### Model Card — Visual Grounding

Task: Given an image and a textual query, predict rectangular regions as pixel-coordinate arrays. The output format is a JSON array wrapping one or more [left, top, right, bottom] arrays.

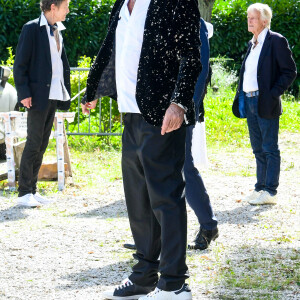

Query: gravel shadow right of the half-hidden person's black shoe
[[215, 204, 273, 224]]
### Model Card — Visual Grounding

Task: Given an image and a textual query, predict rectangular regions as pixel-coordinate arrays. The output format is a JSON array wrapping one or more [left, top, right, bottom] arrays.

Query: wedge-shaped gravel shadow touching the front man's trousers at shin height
[[74, 199, 128, 219]]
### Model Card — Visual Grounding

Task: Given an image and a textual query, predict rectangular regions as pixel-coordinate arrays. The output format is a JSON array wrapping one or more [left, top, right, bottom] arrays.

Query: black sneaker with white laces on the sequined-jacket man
[[102, 278, 154, 300]]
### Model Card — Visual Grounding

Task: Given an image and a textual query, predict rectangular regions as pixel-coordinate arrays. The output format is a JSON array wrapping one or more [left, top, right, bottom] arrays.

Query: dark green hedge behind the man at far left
[[0, 0, 114, 66]]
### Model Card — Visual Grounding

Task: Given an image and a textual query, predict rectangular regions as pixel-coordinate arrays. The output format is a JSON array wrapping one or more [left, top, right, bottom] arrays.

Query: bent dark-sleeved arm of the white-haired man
[[271, 37, 297, 97]]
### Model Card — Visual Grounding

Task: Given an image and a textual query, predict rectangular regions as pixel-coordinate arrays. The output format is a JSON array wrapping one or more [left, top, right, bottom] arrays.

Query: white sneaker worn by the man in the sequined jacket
[[139, 283, 192, 300]]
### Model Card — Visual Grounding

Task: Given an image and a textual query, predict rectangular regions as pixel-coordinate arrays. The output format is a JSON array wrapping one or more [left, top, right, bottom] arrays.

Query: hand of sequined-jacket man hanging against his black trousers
[[161, 103, 184, 135]]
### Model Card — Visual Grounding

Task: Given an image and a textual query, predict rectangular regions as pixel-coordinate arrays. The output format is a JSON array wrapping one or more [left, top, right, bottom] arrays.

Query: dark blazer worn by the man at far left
[[13, 18, 71, 110]]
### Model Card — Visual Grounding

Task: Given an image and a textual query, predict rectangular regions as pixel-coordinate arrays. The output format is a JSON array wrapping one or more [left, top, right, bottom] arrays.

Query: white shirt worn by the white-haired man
[[243, 28, 269, 93]]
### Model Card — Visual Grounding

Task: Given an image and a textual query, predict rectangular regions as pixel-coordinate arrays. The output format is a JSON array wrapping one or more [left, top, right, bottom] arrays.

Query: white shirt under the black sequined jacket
[[116, 0, 150, 113]]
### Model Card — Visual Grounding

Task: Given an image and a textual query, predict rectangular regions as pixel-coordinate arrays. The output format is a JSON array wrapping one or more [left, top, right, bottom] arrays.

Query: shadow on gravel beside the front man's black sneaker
[[55, 258, 134, 290]]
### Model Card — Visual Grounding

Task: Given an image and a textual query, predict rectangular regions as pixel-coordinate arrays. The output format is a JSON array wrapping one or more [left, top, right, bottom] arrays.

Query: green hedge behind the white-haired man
[[211, 0, 300, 95]]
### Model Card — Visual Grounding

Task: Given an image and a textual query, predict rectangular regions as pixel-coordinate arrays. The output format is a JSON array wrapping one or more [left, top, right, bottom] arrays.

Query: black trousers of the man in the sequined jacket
[[122, 113, 188, 291]]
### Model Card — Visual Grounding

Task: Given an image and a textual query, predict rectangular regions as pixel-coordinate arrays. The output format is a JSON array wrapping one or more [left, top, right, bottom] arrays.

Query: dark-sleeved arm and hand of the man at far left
[[13, 25, 33, 103]]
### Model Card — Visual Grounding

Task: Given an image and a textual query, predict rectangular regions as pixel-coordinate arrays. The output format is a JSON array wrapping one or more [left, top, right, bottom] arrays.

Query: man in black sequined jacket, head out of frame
[[82, 0, 201, 300]]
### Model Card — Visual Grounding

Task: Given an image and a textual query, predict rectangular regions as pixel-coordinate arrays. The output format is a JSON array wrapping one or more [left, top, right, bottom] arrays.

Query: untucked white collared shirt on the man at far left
[[40, 13, 70, 101]]
